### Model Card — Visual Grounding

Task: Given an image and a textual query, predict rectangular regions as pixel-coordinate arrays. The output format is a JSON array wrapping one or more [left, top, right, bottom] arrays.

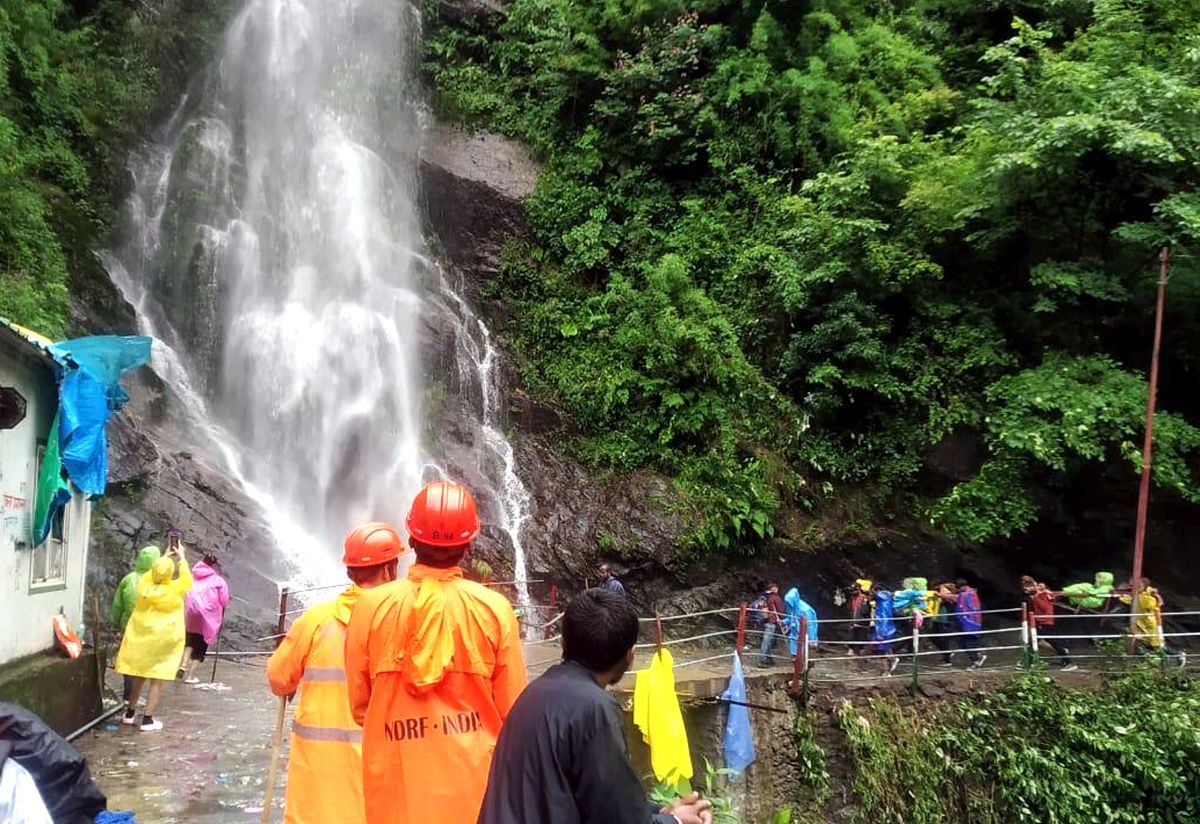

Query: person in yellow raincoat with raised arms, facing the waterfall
[[116, 539, 192, 733]]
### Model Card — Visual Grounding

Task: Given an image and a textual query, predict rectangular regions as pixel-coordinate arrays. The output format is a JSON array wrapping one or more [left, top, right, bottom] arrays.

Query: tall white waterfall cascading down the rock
[[101, 0, 529, 603]]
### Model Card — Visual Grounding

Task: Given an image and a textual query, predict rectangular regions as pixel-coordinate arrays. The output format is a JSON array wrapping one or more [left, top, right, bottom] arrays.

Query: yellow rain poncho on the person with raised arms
[[116, 558, 192, 681]]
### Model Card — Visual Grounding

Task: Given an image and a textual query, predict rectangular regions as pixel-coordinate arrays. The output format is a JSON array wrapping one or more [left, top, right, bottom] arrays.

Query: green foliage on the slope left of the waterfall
[[0, 0, 227, 336]]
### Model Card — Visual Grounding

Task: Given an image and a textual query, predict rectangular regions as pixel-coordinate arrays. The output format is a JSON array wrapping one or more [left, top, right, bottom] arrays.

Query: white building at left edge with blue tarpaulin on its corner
[[0, 320, 91, 664]]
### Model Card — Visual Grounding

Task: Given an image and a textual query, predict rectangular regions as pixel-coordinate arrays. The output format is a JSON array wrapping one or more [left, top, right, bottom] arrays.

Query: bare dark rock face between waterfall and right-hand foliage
[[420, 124, 682, 599]]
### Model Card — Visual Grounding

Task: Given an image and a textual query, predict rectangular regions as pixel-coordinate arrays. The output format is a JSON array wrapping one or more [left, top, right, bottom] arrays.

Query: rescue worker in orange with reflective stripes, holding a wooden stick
[[266, 523, 404, 824]]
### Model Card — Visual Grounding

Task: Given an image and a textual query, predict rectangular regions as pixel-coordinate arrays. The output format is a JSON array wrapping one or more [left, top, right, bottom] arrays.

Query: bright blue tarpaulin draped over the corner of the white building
[[35, 335, 151, 546]]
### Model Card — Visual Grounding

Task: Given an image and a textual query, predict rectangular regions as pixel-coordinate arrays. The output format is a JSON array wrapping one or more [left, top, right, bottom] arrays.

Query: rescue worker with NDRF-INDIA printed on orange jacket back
[[346, 481, 526, 824]]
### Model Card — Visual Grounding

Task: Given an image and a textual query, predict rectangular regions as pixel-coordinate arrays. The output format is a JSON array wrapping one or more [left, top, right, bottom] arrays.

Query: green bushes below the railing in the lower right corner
[[840, 670, 1200, 824]]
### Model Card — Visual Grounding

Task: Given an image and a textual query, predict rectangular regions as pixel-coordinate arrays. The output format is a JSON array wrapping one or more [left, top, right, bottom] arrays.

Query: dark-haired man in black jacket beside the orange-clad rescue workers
[[479, 589, 713, 824]]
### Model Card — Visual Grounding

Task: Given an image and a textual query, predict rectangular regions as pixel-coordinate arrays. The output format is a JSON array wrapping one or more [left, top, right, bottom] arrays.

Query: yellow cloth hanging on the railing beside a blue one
[[634, 649, 692, 784]]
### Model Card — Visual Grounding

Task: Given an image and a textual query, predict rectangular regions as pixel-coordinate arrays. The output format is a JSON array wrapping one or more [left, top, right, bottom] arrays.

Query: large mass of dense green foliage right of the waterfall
[[425, 0, 1200, 548]]
